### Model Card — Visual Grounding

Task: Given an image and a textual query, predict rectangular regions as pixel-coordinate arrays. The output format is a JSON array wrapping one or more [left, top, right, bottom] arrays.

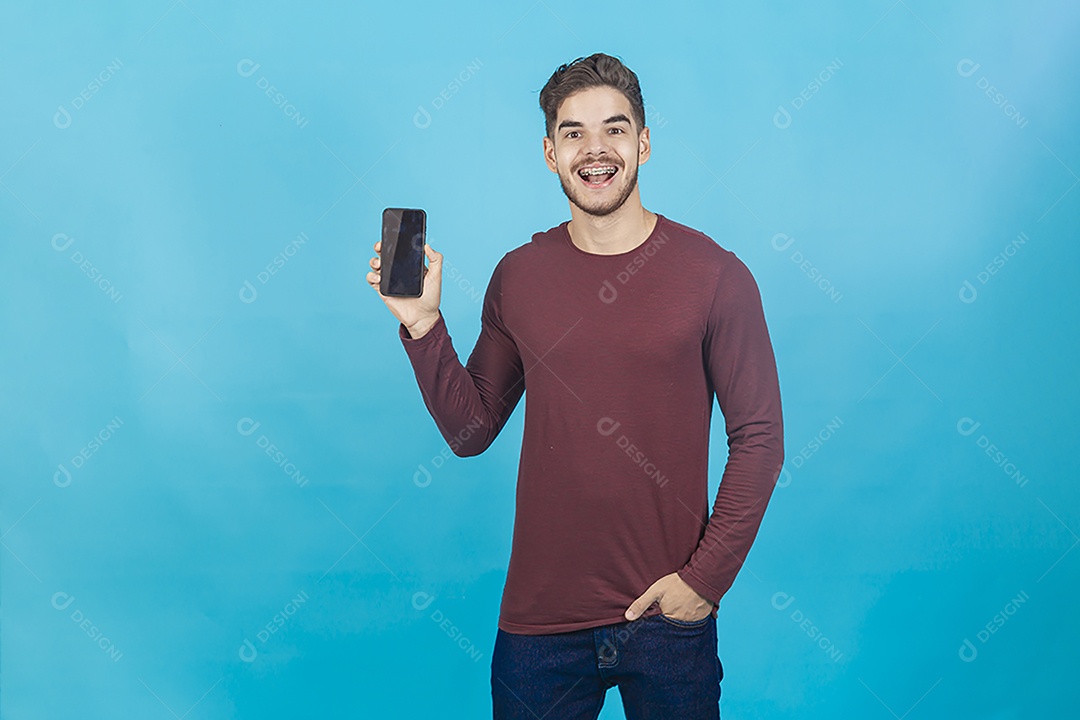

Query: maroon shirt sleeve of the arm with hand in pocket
[[678, 252, 784, 612]]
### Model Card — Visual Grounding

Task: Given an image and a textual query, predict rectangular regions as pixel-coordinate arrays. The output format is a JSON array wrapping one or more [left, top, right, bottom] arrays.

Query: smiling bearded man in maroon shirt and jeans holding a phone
[[367, 53, 784, 719]]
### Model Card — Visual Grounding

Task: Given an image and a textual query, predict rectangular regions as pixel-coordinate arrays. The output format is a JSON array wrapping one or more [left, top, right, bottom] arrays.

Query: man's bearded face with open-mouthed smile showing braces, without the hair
[[543, 86, 649, 216]]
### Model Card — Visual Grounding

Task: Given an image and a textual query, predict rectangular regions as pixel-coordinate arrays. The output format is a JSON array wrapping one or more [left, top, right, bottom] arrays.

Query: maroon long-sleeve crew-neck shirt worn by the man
[[399, 214, 784, 635]]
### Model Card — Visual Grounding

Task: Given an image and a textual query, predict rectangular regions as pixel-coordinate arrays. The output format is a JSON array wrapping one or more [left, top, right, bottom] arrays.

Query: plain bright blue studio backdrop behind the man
[[0, 0, 1080, 720]]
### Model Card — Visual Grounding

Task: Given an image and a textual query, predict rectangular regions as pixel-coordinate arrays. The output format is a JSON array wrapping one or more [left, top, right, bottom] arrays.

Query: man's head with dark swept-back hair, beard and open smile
[[540, 53, 649, 216]]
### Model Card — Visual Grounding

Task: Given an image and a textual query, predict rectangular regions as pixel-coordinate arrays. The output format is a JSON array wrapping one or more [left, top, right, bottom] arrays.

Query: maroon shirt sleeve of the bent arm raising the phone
[[397, 257, 525, 458]]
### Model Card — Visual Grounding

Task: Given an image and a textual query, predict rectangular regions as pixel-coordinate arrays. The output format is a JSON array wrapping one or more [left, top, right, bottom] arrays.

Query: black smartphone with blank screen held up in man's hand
[[379, 207, 428, 298]]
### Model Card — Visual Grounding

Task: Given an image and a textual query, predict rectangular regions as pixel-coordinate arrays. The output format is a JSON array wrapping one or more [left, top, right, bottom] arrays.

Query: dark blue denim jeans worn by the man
[[491, 615, 724, 720]]
